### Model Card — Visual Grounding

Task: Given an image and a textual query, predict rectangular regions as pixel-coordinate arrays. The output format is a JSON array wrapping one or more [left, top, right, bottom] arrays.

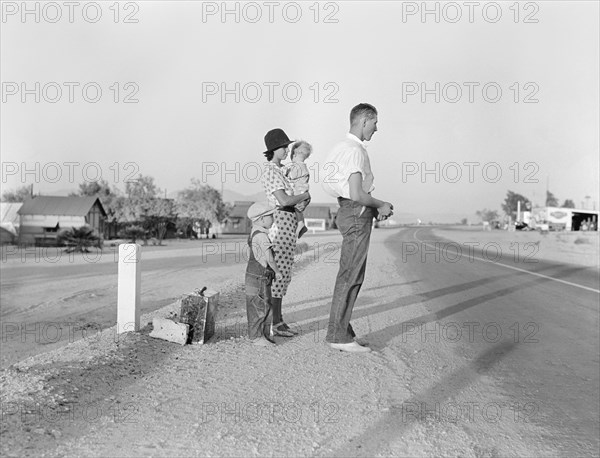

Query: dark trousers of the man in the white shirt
[[325, 198, 377, 343]]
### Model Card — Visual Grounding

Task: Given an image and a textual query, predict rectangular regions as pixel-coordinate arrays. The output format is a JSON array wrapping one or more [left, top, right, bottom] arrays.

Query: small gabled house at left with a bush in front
[[18, 196, 107, 245]]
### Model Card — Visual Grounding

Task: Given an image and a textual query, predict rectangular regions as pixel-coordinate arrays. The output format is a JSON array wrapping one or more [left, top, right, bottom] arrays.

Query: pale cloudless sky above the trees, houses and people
[[0, 1, 600, 222]]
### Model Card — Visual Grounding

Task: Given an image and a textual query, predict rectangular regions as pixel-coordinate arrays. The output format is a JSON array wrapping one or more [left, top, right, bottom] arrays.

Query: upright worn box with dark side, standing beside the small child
[[180, 290, 219, 344]]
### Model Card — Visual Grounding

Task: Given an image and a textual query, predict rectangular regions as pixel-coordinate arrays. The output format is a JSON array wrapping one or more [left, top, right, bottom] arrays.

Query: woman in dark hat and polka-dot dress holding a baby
[[261, 129, 310, 337]]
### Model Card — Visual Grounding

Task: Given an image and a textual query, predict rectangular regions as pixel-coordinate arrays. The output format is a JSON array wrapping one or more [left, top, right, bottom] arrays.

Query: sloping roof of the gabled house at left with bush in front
[[18, 196, 106, 216]]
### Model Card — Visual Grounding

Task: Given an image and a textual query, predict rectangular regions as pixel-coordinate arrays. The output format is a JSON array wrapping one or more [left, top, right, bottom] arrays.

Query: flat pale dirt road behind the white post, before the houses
[[0, 232, 339, 368]]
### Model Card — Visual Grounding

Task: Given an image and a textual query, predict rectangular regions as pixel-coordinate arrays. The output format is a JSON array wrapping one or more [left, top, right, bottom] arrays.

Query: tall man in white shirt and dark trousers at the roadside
[[323, 103, 394, 353]]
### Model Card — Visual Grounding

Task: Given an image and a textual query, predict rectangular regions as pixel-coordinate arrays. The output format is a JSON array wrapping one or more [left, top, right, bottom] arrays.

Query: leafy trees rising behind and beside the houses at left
[[2, 175, 230, 247]]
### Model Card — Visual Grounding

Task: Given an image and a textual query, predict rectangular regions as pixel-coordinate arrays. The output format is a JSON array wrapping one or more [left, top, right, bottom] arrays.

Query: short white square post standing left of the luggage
[[117, 243, 142, 334]]
